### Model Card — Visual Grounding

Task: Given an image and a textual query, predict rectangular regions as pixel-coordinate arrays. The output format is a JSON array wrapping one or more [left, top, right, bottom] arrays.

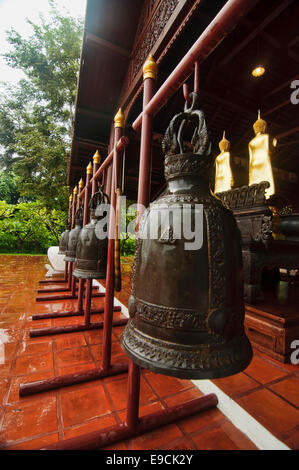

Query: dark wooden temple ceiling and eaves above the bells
[[70, 0, 299, 207]]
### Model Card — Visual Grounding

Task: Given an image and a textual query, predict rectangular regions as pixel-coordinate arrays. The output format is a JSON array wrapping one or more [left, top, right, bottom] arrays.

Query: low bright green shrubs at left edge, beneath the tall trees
[[0, 201, 66, 253]]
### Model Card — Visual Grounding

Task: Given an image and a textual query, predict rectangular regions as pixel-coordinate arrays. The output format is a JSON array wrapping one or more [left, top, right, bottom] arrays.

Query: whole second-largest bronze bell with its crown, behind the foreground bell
[[73, 190, 109, 279]]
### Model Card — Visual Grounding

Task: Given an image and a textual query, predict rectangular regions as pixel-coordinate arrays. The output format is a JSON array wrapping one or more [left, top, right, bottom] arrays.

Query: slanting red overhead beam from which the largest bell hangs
[[133, 0, 258, 130]]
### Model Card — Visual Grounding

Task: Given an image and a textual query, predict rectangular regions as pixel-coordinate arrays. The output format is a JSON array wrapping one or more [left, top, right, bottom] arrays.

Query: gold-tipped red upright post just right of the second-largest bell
[[102, 109, 124, 370]]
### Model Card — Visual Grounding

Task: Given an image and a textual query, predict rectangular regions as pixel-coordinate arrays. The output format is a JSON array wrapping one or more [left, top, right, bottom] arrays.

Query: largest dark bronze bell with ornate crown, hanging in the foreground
[[122, 93, 252, 379]]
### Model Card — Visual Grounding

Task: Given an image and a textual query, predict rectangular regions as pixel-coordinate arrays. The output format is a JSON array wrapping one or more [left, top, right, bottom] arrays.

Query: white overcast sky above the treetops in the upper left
[[0, 0, 86, 84]]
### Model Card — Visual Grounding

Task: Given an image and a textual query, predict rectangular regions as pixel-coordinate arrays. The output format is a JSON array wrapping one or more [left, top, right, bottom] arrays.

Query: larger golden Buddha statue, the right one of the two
[[248, 111, 274, 199]]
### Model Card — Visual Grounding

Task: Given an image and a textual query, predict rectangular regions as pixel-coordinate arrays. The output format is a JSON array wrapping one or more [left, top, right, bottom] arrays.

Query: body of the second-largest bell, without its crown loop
[[73, 217, 108, 279]]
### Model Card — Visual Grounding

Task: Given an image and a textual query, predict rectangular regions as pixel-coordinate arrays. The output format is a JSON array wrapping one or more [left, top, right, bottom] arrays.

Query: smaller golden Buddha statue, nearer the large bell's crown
[[214, 131, 234, 194]]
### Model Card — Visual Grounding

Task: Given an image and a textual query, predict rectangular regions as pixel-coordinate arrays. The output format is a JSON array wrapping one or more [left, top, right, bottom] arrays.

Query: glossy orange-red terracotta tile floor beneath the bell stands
[[0, 255, 299, 450]]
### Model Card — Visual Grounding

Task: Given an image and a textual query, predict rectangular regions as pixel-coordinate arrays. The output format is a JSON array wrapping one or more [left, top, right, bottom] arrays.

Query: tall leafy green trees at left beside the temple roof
[[0, 0, 83, 209]]
